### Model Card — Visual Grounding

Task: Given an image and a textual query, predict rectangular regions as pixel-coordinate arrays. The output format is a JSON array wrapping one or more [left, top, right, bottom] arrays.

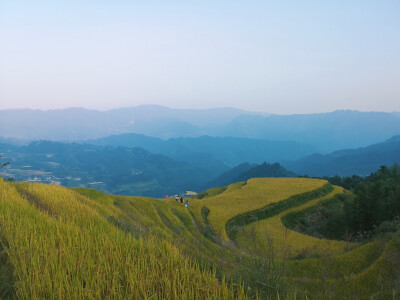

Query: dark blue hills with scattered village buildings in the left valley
[[0, 142, 211, 197]]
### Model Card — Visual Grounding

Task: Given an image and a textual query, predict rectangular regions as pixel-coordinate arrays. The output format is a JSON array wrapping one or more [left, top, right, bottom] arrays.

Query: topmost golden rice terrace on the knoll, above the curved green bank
[[191, 178, 327, 240]]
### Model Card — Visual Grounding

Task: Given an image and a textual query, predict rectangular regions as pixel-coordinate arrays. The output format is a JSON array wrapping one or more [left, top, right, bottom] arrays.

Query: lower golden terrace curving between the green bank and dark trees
[[237, 186, 351, 257]]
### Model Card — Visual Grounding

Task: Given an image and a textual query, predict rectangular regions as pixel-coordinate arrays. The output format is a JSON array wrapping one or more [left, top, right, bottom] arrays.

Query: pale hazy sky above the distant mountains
[[0, 0, 400, 114]]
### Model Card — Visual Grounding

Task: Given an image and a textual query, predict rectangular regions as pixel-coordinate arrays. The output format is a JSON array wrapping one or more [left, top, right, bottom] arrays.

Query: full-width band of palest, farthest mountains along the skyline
[[0, 106, 400, 152]]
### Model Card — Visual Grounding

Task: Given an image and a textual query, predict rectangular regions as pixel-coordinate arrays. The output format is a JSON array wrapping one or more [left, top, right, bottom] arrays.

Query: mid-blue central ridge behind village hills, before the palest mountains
[[87, 134, 316, 171]]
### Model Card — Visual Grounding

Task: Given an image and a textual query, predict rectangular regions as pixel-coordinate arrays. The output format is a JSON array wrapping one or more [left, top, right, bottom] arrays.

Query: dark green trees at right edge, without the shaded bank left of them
[[328, 164, 400, 238]]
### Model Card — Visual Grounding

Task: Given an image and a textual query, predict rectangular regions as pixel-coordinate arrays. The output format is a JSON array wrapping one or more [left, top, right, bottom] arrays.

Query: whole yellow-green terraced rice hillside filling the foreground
[[0, 178, 400, 299]]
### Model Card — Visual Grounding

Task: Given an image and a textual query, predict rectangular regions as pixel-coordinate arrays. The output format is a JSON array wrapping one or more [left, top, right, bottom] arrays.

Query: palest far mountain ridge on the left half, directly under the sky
[[0, 105, 252, 141]]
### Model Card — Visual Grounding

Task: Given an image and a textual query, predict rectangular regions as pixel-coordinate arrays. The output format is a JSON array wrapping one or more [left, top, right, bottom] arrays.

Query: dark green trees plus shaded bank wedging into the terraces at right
[[287, 164, 400, 241]]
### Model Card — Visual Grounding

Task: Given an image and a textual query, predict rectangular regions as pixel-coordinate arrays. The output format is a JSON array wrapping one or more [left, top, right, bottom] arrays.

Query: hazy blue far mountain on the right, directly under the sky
[[218, 110, 400, 153]]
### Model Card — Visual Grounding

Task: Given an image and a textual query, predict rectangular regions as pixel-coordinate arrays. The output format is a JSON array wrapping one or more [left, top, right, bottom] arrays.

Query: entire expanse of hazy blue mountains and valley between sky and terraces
[[0, 106, 400, 197]]
